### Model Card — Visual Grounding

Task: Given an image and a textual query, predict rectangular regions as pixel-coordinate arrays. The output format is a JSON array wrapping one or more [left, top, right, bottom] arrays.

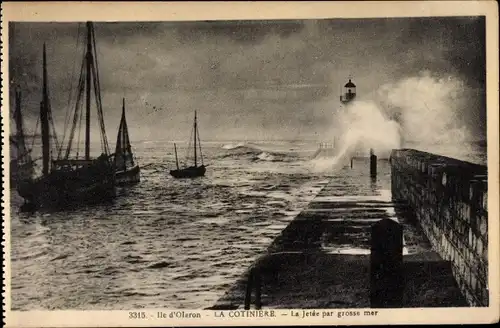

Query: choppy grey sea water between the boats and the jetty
[[11, 142, 484, 310]]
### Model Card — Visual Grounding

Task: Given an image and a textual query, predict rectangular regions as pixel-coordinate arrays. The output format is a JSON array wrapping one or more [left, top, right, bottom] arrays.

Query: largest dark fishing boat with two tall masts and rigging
[[17, 22, 116, 209]]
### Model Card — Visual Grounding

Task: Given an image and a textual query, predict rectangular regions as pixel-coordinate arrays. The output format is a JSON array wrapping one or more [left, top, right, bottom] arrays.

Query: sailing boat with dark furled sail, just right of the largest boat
[[114, 98, 141, 185]]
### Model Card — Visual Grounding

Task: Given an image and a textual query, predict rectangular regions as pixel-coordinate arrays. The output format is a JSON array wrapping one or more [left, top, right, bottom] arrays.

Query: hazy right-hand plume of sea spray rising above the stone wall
[[377, 71, 474, 157]]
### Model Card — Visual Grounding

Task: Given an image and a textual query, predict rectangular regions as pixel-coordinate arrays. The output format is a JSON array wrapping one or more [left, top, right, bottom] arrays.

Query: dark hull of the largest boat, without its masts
[[17, 161, 116, 209]]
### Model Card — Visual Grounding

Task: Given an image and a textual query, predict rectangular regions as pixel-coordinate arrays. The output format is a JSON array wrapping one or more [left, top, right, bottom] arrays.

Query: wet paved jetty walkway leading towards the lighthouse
[[209, 159, 467, 309]]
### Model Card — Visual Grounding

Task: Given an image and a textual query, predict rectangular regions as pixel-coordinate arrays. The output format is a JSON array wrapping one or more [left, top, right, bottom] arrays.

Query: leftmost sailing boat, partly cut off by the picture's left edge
[[10, 90, 34, 188]]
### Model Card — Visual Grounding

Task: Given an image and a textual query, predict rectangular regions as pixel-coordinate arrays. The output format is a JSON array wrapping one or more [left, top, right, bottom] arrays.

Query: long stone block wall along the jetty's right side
[[391, 149, 489, 306]]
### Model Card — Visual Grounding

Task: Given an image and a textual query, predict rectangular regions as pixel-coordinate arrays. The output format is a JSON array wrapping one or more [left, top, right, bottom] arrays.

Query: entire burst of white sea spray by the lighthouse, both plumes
[[310, 71, 476, 172]]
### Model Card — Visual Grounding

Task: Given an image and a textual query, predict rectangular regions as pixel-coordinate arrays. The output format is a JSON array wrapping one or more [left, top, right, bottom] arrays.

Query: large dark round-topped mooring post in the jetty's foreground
[[370, 219, 404, 308]]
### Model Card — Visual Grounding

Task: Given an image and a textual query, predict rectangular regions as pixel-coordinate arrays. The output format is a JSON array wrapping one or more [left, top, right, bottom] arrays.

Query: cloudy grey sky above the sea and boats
[[9, 17, 486, 144]]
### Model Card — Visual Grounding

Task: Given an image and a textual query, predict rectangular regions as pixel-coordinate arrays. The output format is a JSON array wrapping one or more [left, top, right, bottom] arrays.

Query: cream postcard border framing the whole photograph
[[2, 1, 500, 327]]
